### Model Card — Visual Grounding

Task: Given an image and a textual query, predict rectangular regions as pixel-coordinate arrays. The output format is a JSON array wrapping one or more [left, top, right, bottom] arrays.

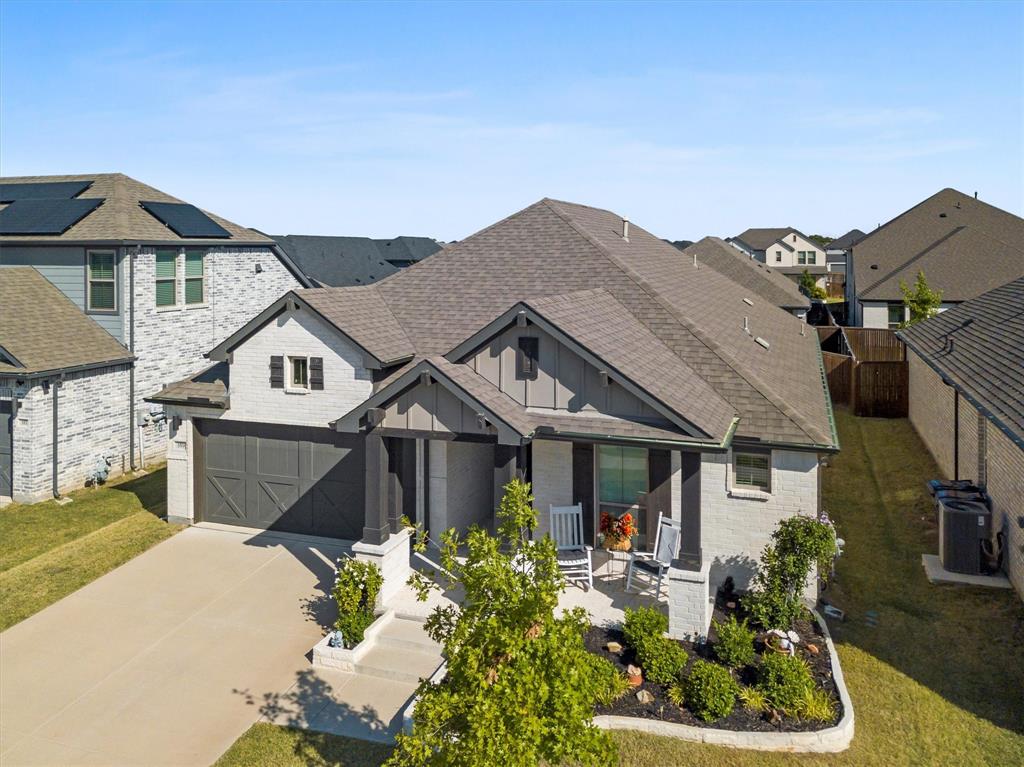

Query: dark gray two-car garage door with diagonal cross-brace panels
[[196, 420, 365, 541]]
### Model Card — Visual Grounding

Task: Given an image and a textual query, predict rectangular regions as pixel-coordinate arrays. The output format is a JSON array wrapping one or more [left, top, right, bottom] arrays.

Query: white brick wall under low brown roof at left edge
[[0, 365, 128, 503]]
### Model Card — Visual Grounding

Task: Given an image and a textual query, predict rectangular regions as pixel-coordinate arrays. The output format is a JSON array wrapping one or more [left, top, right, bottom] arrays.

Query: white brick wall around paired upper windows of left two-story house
[[128, 248, 301, 463]]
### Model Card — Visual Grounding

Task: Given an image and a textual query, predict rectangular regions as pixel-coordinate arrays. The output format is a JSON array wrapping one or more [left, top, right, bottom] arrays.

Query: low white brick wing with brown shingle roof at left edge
[[0, 266, 132, 502]]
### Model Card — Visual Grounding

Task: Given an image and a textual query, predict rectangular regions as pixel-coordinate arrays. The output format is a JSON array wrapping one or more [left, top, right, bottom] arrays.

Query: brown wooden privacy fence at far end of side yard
[[818, 328, 909, 418]]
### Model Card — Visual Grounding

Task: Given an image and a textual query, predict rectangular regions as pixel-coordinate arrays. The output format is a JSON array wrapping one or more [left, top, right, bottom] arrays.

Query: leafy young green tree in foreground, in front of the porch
[[387, 479, 616, 767]]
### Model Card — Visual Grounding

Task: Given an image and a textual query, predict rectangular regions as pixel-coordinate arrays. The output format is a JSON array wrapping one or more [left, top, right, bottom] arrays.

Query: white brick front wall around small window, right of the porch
[[700, 450, 818, 592]]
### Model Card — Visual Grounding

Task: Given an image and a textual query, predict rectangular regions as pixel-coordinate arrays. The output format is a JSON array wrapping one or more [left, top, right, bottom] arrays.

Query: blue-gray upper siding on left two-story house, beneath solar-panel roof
[[0, 245, 125, 343]]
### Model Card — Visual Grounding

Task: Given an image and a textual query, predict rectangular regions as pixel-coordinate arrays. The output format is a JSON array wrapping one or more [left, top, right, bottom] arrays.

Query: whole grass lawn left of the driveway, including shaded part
[[0, 469, 179, 631]]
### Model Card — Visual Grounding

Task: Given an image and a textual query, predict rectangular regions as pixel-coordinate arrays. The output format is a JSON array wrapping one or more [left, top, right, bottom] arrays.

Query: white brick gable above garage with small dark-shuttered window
[[226, 309, 373, 427]]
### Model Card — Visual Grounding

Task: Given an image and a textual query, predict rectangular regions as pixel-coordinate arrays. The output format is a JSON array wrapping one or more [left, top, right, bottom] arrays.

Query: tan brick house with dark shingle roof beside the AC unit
[[898, 278, 1024, 597]]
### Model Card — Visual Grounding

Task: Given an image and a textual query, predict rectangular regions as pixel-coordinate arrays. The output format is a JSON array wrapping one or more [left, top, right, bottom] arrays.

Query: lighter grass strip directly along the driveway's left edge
[[0, 511, 180, 631]]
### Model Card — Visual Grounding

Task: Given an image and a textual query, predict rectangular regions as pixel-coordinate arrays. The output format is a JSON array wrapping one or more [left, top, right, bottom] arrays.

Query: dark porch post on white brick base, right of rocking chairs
[[669, 453, 714, 641]]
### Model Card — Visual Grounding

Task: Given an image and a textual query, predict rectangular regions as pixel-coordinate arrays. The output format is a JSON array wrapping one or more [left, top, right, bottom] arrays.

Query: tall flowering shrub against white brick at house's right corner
[[744, 515, 838, 629]]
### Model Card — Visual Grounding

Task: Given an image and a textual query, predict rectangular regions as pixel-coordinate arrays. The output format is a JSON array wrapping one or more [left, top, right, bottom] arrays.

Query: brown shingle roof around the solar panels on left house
[[0, 173, 273, 245]]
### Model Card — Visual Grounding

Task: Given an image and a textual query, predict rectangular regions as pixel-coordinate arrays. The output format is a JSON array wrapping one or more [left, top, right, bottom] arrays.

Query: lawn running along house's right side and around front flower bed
[[218, 411, 1024, 767]]
